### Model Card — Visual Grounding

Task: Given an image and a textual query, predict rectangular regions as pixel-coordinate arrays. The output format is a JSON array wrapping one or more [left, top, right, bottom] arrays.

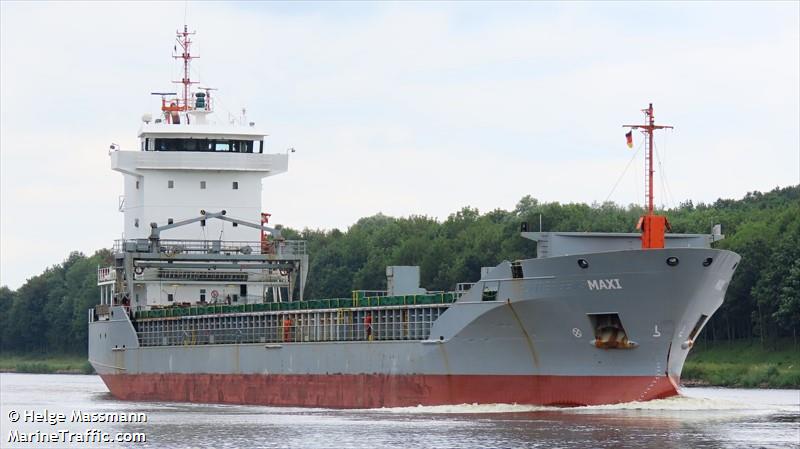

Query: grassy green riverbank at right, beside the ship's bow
[[681, 340, 800, 388]]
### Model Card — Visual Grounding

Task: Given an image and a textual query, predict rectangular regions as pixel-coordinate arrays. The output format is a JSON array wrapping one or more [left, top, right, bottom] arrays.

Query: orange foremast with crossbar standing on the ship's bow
[[622, 103, 673, 249]]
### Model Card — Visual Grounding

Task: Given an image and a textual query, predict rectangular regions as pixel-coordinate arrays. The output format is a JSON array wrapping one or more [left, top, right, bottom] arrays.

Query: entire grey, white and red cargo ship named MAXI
[[88, 26, 740, 408]]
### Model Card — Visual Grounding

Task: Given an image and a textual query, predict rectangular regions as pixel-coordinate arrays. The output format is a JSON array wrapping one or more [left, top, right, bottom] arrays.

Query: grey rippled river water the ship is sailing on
[[0, 374, 800, 448]]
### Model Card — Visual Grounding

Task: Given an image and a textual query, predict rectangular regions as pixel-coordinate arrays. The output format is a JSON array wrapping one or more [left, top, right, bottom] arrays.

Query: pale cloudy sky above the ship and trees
[[0, 1, 800, 289]]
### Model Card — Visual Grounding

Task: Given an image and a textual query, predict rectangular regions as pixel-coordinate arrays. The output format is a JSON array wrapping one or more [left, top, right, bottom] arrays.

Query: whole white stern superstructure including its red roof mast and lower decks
[[98, 27, 308, 310]]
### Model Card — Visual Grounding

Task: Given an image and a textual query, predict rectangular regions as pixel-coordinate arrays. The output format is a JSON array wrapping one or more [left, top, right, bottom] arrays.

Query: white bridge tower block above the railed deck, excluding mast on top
[[111, 122, 288, 241]]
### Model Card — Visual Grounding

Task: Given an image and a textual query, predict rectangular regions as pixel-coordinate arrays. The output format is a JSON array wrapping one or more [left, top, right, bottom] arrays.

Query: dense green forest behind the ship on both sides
[[0, 186, 800, 354]]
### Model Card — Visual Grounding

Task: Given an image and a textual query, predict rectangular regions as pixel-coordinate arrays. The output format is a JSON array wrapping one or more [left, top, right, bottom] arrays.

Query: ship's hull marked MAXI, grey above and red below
[[89, 248, 740, 408]]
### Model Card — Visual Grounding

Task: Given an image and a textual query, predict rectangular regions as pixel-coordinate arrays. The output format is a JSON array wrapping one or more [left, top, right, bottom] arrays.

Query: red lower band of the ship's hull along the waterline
[[102, 374, 678, 408]]
